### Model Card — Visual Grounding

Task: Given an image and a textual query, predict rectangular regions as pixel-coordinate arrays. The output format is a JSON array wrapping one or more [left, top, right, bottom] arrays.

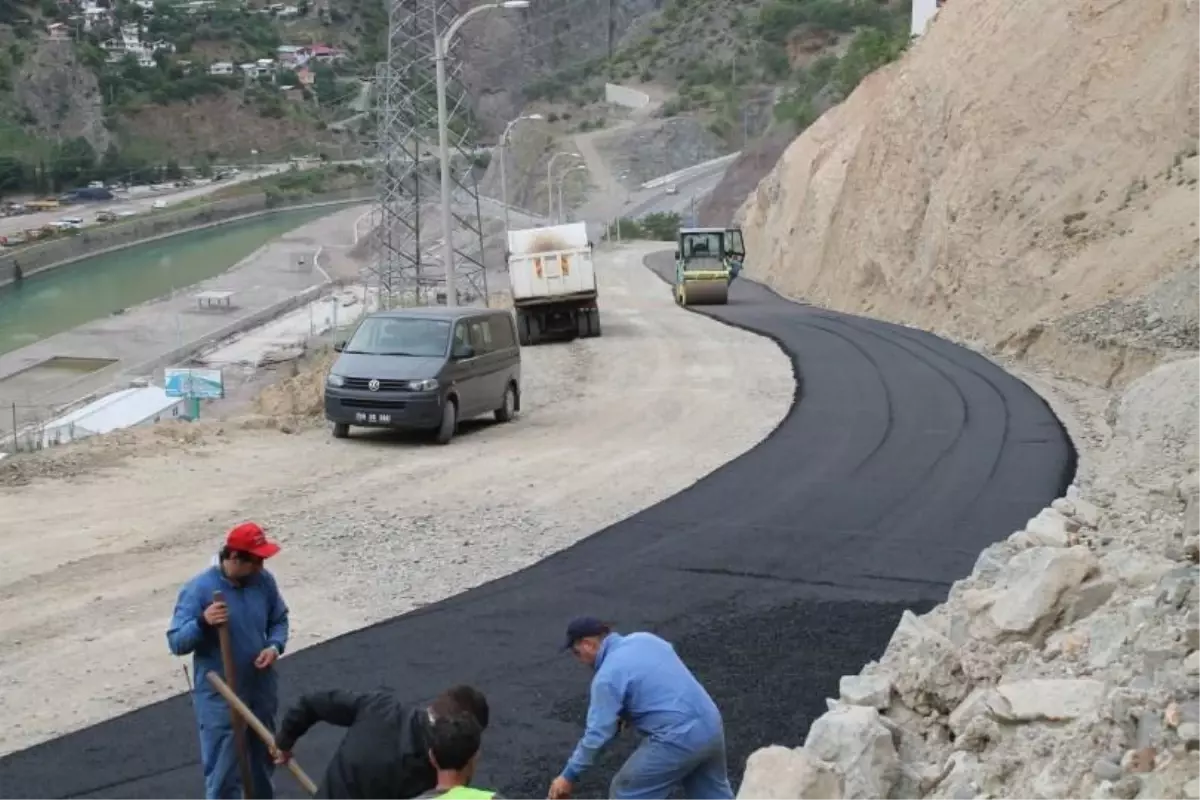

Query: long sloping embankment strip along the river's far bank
[[0, 188, 374, 287]]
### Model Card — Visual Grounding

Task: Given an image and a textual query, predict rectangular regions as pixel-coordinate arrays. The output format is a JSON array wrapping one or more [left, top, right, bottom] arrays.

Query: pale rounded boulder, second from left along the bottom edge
[[804, 705, 900, 800]]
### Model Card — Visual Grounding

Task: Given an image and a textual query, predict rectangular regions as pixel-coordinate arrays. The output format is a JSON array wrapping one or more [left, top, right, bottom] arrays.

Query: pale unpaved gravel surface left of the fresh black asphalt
[[0, 243, 794, 754]]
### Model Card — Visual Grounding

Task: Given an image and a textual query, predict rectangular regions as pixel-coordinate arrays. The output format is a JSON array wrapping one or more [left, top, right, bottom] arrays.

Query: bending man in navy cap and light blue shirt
[[548, 616, 733, 800]]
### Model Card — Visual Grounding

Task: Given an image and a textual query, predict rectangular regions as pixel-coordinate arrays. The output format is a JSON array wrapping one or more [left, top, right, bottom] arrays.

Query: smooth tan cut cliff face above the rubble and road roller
[[738, 0, 1200, 383]]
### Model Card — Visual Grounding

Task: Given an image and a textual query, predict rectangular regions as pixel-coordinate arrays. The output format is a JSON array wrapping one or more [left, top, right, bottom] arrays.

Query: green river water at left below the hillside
[[0, 207, 336, 354]]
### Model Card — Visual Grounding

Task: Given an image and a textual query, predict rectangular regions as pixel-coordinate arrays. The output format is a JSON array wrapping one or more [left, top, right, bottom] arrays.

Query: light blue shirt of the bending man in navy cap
[[563, 633, 722, 783]]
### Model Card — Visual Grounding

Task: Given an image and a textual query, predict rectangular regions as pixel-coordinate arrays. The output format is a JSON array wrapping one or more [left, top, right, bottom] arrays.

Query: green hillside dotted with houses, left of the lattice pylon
[[0, 0, 384, 192]]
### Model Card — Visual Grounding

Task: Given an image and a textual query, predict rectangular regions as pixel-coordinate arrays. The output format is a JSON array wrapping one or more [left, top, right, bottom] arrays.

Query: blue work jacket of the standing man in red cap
[[167, 566, 288, 724]]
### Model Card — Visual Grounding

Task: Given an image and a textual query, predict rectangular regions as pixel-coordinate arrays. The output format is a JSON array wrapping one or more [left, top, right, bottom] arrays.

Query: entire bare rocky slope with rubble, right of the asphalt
[[724, 0, 1200, 800]]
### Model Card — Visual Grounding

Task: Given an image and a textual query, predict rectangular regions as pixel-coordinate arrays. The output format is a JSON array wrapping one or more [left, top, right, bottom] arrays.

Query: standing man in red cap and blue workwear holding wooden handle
[[167, 522, 288, 800]]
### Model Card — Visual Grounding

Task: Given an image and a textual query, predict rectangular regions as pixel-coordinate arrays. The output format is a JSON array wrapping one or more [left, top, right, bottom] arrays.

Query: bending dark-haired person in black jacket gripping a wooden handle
[[275, 686, 488, 800]]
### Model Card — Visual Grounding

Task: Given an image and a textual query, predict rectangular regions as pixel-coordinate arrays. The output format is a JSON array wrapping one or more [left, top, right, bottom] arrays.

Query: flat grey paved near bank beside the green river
[[0, 204, 367, 449]]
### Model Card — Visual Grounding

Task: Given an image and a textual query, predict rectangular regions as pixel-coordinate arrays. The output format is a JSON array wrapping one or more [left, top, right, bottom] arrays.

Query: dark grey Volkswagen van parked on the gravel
[[325, 306, 521, 444]]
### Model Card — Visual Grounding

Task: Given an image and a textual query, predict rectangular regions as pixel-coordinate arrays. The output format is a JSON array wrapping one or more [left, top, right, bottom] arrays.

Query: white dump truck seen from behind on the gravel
[[508, 222, 600, 345]]
